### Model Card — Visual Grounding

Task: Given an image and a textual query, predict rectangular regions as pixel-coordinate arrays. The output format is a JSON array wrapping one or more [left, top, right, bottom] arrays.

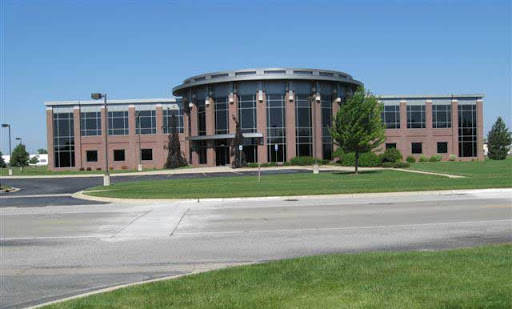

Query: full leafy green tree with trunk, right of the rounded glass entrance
[[330, 87, 386, 174]]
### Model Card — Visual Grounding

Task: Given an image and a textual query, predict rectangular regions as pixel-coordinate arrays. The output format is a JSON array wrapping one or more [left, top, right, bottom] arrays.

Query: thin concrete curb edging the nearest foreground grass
[[27, 262, 257, 309]]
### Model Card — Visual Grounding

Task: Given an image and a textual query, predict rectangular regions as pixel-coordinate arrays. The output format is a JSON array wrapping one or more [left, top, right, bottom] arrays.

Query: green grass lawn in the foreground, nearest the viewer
[[45, 244, 512, 309]]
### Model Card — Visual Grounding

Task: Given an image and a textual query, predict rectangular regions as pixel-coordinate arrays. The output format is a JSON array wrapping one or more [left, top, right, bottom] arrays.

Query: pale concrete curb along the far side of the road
[[72, 188, 512, 204]]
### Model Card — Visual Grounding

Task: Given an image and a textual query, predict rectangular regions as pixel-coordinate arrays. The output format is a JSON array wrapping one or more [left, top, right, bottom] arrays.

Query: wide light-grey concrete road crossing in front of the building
[[0, 190, 512, 308]]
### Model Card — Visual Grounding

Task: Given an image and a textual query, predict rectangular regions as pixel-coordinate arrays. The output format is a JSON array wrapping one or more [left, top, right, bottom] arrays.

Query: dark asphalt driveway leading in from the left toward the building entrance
[[0, 169, 310, 207]]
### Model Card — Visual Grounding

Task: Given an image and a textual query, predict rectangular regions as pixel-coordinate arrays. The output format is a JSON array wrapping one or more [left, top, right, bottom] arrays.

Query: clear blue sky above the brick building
[[0, 0, 512, 153]]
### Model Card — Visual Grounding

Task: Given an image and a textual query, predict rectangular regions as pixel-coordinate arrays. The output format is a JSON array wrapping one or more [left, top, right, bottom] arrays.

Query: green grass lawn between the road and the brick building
[[87, 160, 512, 199]]
